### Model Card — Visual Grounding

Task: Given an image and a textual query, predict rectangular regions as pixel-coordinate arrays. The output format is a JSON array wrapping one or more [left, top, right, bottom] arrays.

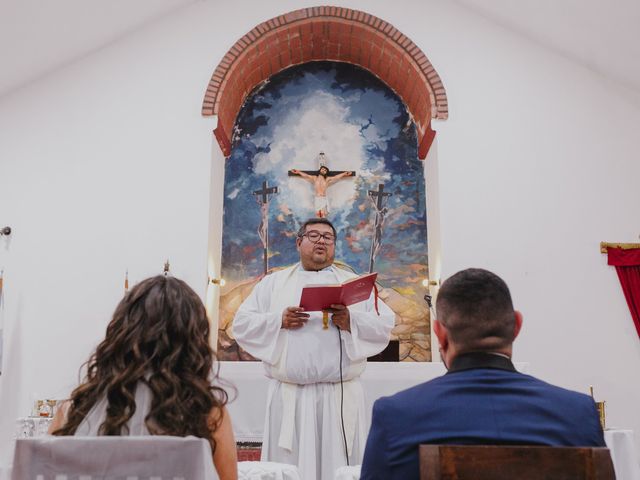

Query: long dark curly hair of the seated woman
[[53, 275, 228, 450]]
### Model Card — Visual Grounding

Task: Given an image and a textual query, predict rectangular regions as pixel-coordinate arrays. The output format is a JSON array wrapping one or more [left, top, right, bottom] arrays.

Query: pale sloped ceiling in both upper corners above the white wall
[[0, 0, 640, 97]]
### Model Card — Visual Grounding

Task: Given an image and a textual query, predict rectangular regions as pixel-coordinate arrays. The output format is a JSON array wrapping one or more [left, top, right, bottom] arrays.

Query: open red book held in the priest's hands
[[300, 272, 378, 312]]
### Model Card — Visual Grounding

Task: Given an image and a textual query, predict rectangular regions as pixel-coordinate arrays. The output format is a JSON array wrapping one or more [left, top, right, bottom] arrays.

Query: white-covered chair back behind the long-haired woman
[[11, 436, 218, 480]]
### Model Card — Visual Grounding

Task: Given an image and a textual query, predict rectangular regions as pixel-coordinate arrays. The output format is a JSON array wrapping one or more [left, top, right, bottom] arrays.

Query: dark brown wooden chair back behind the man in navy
[[420, 445, 615, 480]]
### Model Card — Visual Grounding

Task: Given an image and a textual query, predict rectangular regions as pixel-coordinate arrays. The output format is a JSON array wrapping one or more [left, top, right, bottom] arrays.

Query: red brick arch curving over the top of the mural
[[202, 7, 449, 159]]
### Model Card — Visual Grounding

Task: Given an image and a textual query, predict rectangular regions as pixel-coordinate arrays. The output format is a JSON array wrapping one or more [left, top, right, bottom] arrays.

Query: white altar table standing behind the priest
[[219, 362, 529, 442]]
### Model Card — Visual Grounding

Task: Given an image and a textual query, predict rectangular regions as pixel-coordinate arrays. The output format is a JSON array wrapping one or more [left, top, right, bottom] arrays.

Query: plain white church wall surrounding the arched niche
[[0, 1, 640, 465]]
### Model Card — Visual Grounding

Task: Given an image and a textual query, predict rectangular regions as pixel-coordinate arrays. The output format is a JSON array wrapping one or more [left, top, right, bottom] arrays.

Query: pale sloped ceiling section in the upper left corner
[[0, 0, 199, 97]]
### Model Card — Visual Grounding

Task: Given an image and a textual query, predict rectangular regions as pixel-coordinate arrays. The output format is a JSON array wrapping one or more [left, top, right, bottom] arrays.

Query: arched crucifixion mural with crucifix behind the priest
[[218, 62, 431, 361]]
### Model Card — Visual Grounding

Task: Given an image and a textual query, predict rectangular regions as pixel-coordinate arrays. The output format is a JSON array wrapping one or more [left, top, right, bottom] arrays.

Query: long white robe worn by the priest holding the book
[[233, 264, 394, 480]]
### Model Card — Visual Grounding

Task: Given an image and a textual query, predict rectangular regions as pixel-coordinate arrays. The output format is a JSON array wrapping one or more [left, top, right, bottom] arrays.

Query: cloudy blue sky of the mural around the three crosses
[[222, 62, 427, 296]]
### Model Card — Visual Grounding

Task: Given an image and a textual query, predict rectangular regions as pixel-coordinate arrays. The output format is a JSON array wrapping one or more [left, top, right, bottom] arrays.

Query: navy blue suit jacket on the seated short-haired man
[[360, 353, 605, 480]]
